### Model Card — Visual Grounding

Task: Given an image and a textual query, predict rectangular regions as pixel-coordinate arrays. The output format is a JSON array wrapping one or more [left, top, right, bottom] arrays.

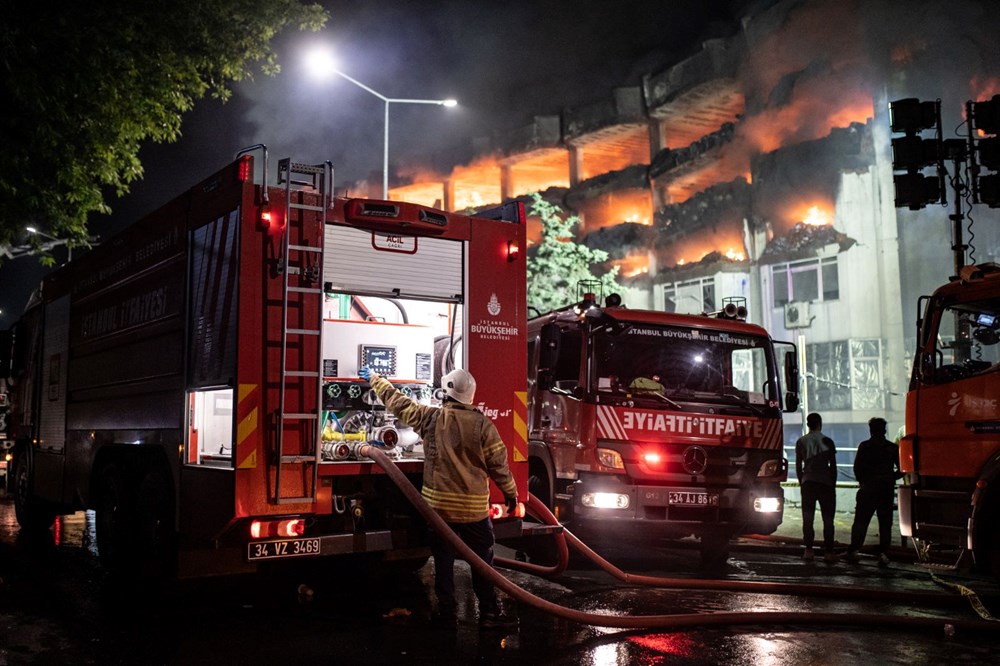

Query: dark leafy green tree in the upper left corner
[[0, 0, 327, 260]]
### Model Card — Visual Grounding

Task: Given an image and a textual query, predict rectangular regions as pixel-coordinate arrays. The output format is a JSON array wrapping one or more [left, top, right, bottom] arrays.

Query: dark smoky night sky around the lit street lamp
[[0, 0, 746, 327]]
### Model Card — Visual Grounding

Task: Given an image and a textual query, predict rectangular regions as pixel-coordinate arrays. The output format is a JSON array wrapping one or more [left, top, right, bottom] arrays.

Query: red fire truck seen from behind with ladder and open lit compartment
[[0, 146, 527, 577]]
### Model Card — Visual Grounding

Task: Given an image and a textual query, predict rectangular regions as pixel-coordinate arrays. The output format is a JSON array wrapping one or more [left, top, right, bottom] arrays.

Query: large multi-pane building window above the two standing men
[[806, 339, 885, 411]]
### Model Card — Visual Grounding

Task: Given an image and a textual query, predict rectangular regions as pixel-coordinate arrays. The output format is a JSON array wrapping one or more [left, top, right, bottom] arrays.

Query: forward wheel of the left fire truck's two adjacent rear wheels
[[94, 463, 135, 571]]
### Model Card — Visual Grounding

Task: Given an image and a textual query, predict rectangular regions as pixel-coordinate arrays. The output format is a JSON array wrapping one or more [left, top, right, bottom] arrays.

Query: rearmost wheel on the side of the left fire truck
[[134, 463, 177, 578]]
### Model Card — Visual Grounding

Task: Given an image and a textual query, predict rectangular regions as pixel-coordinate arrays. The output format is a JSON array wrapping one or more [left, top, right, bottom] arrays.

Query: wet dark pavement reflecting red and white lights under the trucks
[[0, 486, 1000, 666]]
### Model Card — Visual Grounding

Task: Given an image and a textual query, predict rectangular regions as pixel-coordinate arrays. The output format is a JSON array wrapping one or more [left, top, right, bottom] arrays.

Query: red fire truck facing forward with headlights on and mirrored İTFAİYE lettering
[[528, 293, 798, 564]]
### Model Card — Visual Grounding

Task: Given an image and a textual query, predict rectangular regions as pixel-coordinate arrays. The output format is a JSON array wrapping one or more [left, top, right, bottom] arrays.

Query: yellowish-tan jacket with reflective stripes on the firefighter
[[371, 373, 517, 523]]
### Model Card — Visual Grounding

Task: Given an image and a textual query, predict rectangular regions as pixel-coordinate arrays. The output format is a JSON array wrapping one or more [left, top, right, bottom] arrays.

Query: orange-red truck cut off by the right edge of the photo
[[899, 264, 1000, 575]]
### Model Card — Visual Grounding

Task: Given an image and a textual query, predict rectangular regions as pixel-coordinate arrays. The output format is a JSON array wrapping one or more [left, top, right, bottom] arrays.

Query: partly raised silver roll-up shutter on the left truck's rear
[[323, 225, 464, 301]]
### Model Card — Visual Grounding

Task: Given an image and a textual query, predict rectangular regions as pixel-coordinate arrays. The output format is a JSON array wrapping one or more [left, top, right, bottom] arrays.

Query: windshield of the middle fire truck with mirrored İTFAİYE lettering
[[591, 324, 777, 412]]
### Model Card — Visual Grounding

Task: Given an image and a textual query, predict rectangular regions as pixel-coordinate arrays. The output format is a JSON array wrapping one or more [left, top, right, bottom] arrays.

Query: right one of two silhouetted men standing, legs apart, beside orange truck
[[845, 417, 903, 567]]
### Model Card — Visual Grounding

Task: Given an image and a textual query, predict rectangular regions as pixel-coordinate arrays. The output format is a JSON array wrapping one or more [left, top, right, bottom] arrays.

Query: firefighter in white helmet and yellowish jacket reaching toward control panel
[[358, 367, 517, 629]]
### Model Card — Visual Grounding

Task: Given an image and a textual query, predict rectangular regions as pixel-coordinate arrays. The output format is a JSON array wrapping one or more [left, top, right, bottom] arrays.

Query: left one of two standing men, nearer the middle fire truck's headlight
[[795, 412, 837, 564]]
